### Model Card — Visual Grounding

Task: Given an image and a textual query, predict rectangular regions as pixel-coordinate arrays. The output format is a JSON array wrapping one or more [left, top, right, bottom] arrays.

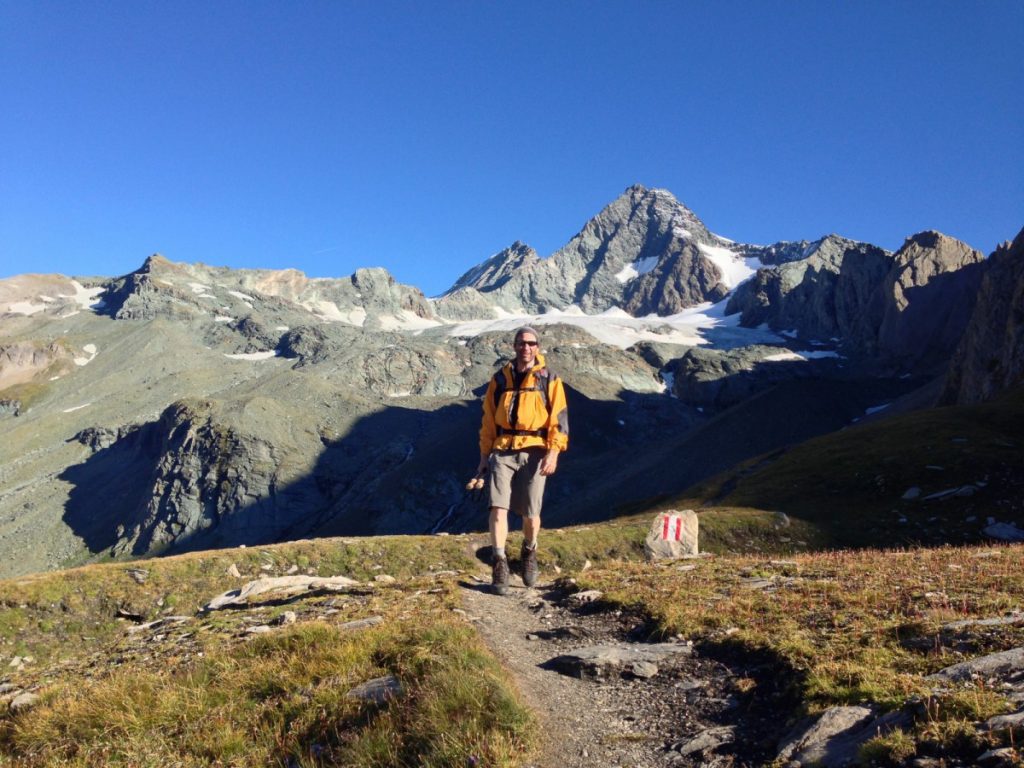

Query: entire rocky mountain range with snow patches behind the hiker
[[0, 186, 1020, 572]]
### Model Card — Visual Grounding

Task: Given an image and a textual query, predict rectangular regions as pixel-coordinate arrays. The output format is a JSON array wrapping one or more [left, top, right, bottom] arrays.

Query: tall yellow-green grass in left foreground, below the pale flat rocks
[[0, 588, 531, 767]]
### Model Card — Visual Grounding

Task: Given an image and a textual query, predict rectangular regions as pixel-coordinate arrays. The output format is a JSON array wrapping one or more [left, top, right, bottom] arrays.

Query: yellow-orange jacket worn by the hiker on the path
[[480, 353, 569, 456]]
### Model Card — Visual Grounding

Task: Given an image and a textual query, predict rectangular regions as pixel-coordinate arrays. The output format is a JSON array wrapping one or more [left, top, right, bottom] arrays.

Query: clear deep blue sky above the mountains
[[0, 0, 1024, 295]]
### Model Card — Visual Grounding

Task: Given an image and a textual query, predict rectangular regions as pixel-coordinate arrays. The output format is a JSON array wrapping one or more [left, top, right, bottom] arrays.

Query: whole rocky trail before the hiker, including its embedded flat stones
[[462, 575, 778, 768]]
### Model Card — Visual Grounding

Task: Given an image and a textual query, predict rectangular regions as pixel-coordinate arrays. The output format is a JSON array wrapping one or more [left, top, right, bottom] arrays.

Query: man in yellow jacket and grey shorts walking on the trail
[[477, 327, 569, 595]]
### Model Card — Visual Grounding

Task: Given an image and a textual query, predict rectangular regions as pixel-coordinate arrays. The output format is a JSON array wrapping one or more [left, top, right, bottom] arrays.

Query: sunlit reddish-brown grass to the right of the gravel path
[[579, 546, 1024, 765]]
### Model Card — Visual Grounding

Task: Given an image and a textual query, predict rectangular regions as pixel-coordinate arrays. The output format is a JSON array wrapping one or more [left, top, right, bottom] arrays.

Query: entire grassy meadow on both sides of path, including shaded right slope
[[0, 393, 1024, 768]]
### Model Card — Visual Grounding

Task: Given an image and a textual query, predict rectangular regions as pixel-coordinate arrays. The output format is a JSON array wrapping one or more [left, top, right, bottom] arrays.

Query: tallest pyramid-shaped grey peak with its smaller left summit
[[440, 185, 728, 316]]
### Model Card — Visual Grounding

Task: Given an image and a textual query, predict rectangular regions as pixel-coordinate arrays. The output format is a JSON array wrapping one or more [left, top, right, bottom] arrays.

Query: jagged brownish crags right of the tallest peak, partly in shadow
[[726, 231, 983, 371]]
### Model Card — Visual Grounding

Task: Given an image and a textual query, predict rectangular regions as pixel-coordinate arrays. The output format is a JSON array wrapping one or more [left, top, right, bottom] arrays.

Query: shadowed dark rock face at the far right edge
[[942, 229, 1024, 403]]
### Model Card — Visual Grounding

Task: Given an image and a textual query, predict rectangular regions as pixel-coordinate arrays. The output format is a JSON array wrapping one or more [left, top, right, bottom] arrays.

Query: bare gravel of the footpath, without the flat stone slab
[[462, 573, 761, 768]]
